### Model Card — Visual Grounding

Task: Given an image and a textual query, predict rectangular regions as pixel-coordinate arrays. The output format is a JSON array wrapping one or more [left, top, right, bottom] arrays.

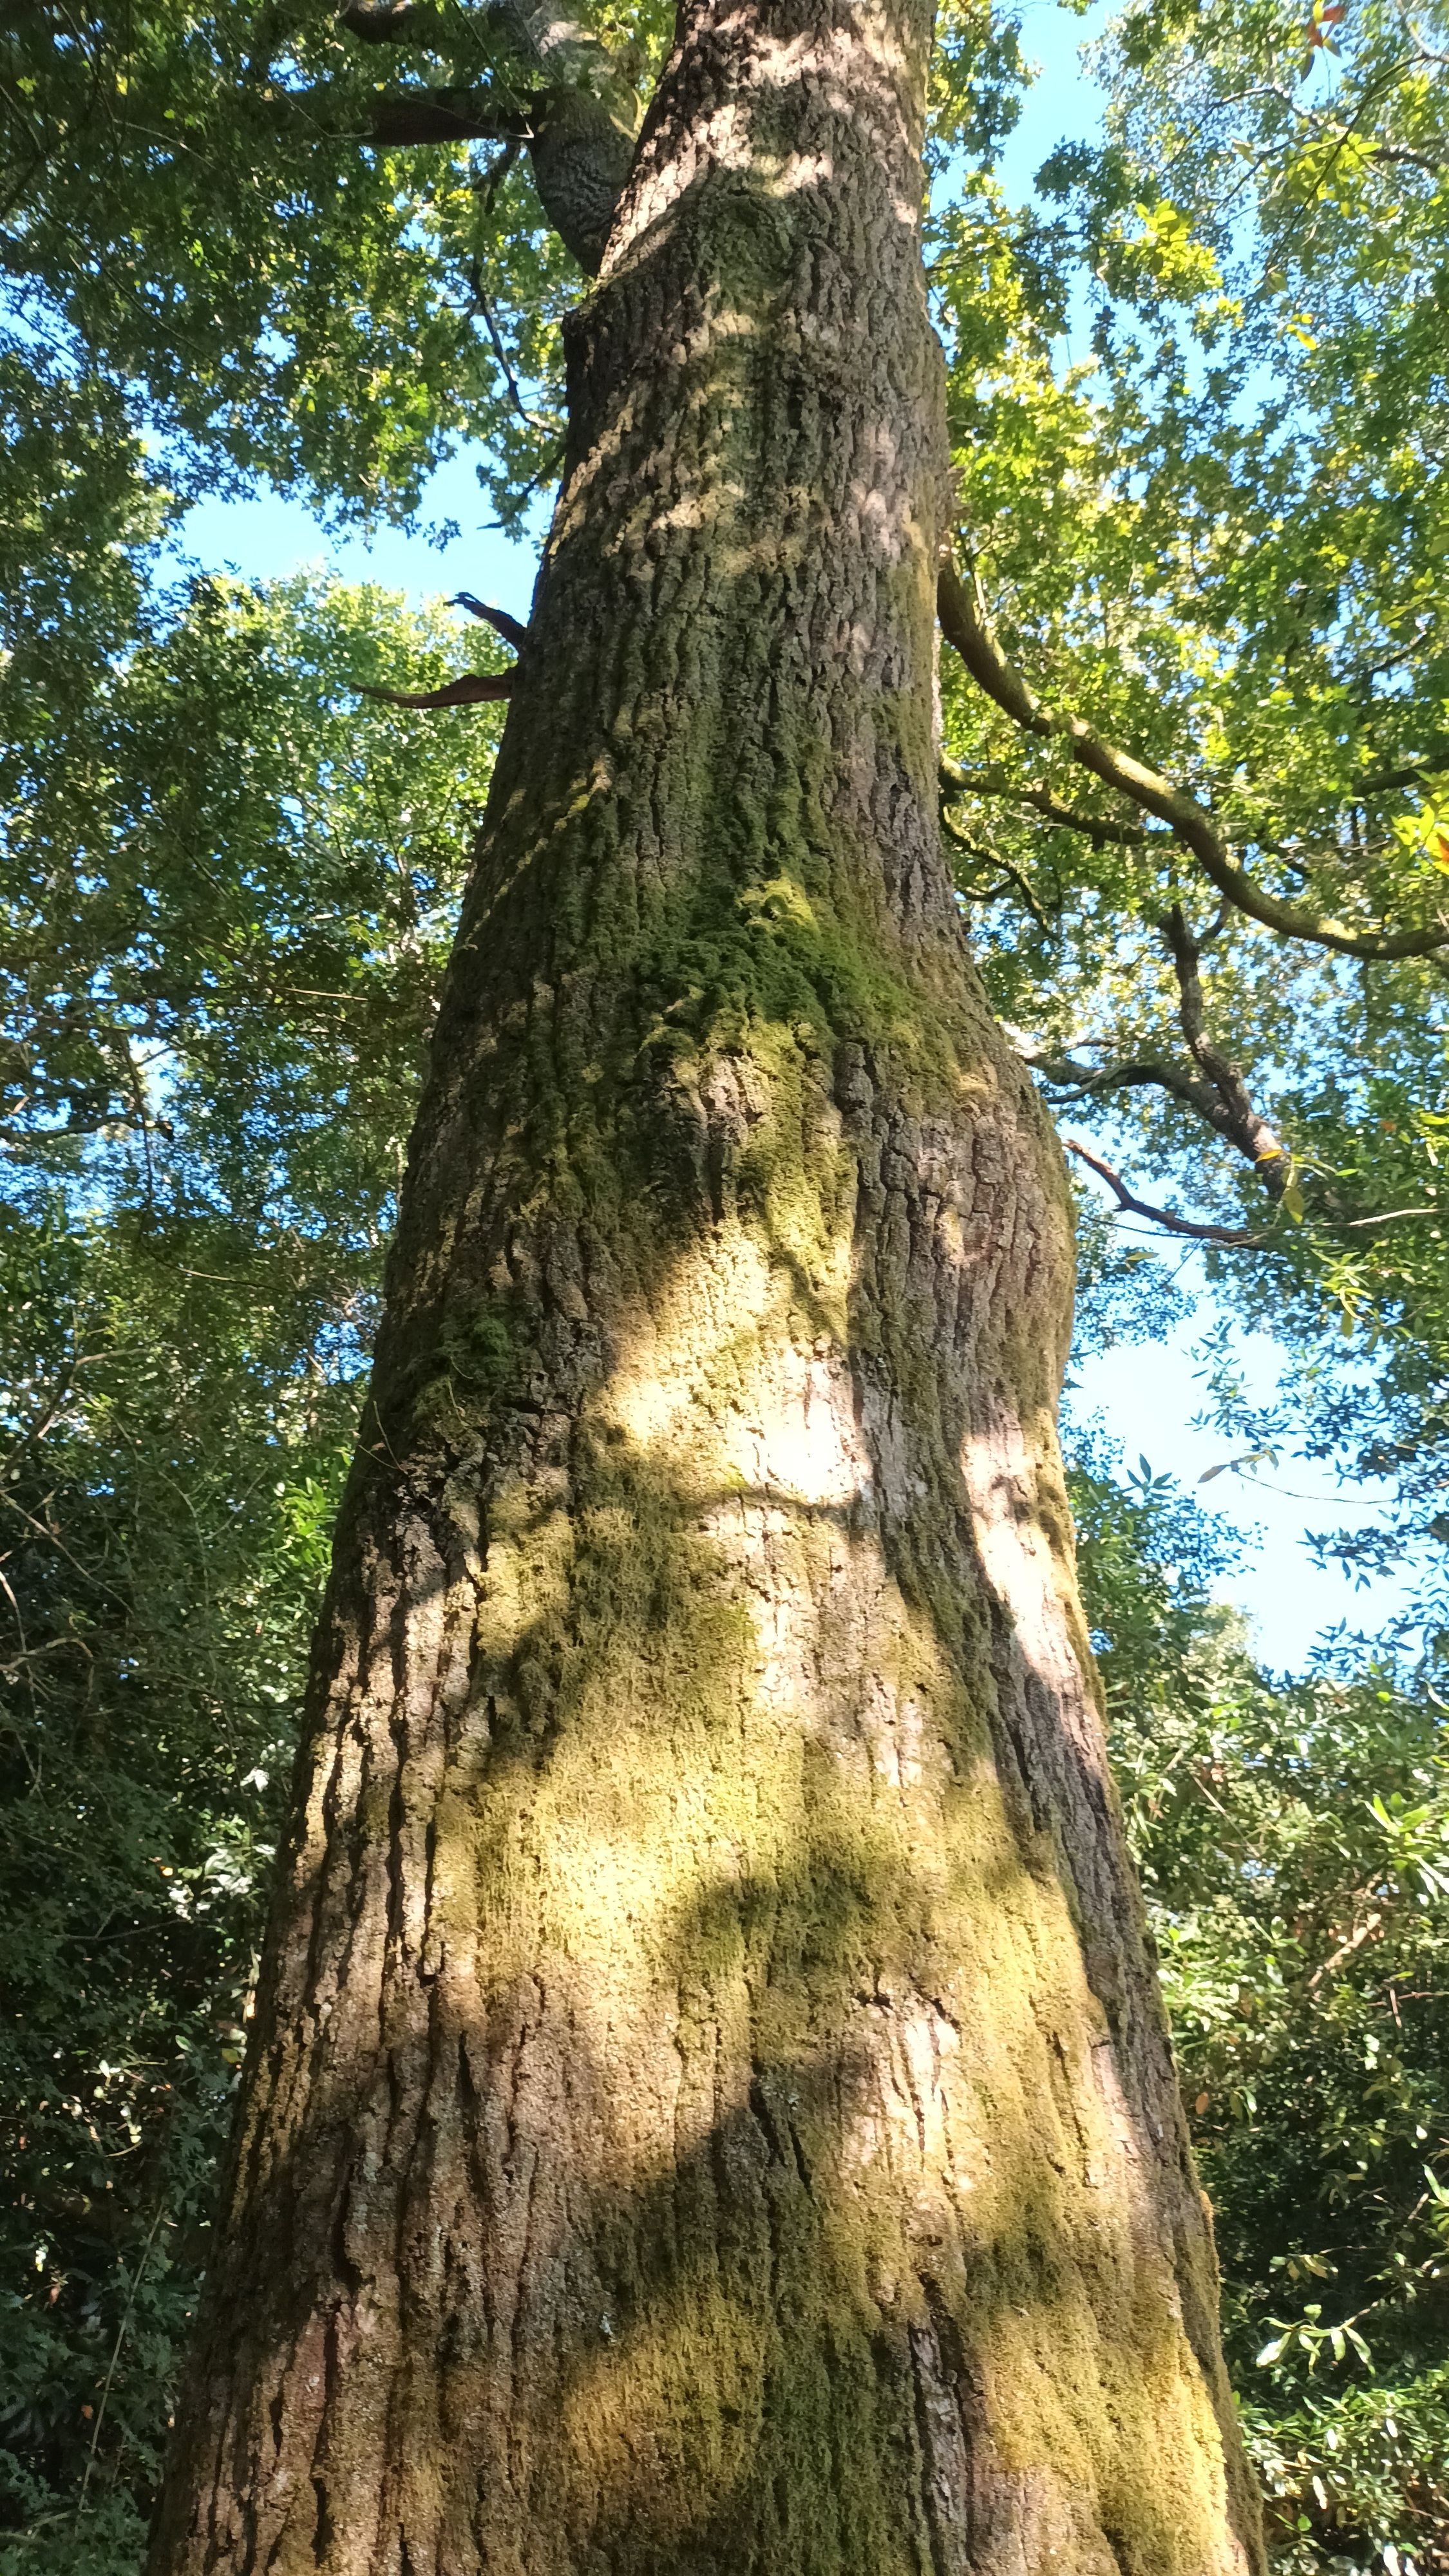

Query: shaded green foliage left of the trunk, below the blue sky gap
[[0, 582, 502, 2576]]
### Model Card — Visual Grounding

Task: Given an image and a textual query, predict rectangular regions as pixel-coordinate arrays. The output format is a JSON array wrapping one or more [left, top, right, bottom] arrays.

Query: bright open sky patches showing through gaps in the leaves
[[171, 0, 1403, 1669]]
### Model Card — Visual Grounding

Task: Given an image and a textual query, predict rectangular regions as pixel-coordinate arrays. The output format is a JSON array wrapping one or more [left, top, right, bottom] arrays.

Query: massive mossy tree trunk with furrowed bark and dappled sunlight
[[152, 0, 1258, 2576]]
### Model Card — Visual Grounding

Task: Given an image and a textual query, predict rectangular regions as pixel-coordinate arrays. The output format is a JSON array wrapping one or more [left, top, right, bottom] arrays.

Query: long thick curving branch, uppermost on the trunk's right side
[[936, 556, 1449, 958]]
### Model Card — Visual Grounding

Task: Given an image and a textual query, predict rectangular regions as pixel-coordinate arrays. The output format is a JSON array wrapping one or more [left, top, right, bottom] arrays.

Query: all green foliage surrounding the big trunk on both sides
[[0, 0, 1449, 2576]]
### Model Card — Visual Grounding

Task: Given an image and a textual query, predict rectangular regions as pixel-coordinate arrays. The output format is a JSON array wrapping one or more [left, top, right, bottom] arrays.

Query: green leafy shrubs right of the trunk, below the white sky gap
[[1072, 1437, 1449, 2571]]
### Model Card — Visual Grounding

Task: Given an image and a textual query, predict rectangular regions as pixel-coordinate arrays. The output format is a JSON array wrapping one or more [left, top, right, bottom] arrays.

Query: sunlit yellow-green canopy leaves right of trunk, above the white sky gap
[[931, 0, 1449, 1651]]
